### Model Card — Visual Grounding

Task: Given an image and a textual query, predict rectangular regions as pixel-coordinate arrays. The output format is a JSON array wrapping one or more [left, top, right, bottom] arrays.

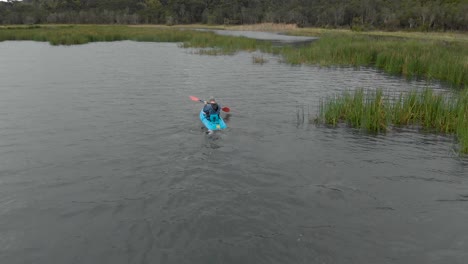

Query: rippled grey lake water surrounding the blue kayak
[[0, 41, 468, 264]]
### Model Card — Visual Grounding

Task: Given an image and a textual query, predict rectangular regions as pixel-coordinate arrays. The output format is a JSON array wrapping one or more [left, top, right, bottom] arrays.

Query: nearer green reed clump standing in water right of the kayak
[[315, 89, 468, 153]]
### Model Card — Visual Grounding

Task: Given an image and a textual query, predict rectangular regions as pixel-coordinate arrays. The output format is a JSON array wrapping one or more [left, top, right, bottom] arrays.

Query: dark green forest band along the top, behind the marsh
[[0, 0, 468, 31]]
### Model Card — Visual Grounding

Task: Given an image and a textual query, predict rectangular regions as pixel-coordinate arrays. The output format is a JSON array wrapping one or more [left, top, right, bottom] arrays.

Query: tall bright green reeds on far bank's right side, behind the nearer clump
[[282, 33, 468, 87]]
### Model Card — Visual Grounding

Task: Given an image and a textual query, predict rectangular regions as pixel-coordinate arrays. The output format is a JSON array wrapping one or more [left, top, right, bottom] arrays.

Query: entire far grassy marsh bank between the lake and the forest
[[0, 24, 468, 88]]
